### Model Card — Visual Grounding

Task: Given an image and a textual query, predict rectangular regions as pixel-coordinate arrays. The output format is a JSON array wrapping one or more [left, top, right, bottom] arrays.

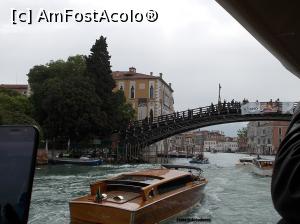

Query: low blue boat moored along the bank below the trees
[[49, 156, 103, 166]]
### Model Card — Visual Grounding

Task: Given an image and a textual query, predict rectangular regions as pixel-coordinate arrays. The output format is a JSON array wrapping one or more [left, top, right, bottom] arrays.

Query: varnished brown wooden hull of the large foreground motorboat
[[70, 184, 205, 224]]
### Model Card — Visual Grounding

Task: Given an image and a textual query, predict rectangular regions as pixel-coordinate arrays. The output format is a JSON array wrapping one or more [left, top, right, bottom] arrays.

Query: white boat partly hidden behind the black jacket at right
[[252, 158, 274, 177]]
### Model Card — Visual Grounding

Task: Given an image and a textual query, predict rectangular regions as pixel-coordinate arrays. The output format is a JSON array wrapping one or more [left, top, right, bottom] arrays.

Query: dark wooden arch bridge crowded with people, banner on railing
[[120, 101, 297, 160]]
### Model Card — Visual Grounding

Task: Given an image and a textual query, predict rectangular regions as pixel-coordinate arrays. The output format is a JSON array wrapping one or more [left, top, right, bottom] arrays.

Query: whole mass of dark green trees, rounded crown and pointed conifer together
[[28, 36, 134, 143]]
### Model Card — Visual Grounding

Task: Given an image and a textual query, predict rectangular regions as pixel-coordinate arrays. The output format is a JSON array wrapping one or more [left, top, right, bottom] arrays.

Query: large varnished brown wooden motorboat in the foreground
[[69, 165, 207, 224]]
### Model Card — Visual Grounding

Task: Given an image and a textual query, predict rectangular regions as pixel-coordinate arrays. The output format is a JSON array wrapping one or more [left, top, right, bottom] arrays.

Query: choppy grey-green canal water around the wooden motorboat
[[29, 153, 280, 224]]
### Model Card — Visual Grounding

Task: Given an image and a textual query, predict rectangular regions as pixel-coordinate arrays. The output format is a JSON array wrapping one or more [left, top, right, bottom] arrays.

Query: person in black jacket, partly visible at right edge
[[271, 103, 300, 223]]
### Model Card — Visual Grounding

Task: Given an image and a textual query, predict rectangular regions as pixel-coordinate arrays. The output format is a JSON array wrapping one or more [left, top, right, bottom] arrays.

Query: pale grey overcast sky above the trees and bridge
[[0, 0, 300, 135]]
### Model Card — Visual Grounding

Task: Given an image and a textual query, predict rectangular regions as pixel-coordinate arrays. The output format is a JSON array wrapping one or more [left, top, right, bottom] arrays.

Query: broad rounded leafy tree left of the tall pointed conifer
[[28, 55, 105, 141]]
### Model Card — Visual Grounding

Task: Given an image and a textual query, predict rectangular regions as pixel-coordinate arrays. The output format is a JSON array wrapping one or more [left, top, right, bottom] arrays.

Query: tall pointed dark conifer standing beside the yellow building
[[86, 36, 134, 134]]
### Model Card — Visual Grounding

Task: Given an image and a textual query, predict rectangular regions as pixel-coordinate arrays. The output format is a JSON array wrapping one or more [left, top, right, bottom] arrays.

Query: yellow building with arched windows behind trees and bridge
[[112, 67, 174, 160]]
